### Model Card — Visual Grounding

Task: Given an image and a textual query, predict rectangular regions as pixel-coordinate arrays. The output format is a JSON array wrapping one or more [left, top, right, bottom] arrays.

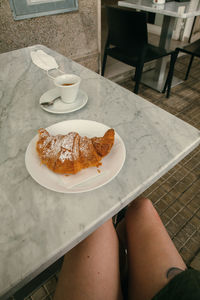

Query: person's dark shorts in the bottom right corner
[[152, 269, 200, 300]]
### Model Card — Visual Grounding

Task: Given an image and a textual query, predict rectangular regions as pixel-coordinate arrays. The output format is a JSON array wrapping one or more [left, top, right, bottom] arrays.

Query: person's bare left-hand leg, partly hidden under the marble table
[[54, 220, 122, 300]]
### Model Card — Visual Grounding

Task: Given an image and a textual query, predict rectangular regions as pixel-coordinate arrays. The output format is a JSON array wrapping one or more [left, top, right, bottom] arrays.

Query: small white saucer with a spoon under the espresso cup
[[39, 88, 88, 114]]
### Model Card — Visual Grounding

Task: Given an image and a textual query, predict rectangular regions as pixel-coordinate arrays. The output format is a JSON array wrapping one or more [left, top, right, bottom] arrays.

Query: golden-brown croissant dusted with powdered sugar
[[36, 128, 115, 174]]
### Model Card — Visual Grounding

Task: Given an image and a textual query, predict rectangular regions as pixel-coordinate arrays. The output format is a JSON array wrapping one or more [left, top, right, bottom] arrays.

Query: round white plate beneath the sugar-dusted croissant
[[25, 120, 126, 193]]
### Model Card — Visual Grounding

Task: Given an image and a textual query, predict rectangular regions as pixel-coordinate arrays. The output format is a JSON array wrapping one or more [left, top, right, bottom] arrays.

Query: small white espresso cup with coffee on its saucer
[[54, 74, 81, 103]]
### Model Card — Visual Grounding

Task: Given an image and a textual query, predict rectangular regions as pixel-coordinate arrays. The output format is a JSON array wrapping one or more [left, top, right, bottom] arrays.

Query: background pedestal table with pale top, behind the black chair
[[118, 0, 200, 91]]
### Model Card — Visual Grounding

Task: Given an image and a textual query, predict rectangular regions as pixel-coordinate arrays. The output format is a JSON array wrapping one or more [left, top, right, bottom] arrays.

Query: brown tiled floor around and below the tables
[[12, 57, 200, 300]]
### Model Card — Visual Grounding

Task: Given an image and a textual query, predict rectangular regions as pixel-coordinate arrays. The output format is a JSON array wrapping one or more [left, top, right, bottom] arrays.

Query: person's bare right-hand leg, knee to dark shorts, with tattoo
[[125, 198, 186, 300]]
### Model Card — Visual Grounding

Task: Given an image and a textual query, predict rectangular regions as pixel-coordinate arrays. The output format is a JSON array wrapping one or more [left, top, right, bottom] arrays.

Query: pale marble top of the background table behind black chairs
[[118, 0, 200, 19]]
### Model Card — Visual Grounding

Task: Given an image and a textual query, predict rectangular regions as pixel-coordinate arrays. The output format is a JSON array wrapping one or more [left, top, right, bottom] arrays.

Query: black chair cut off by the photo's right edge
[[163, 39, 200, 94]]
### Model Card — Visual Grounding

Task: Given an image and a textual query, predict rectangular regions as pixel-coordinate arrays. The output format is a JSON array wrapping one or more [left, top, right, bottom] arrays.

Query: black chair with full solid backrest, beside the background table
[[102, 6, 174, 94]]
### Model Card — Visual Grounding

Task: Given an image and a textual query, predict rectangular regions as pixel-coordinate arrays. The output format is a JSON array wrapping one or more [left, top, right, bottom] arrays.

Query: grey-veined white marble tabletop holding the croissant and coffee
[[0, 45, 200, 299]]
